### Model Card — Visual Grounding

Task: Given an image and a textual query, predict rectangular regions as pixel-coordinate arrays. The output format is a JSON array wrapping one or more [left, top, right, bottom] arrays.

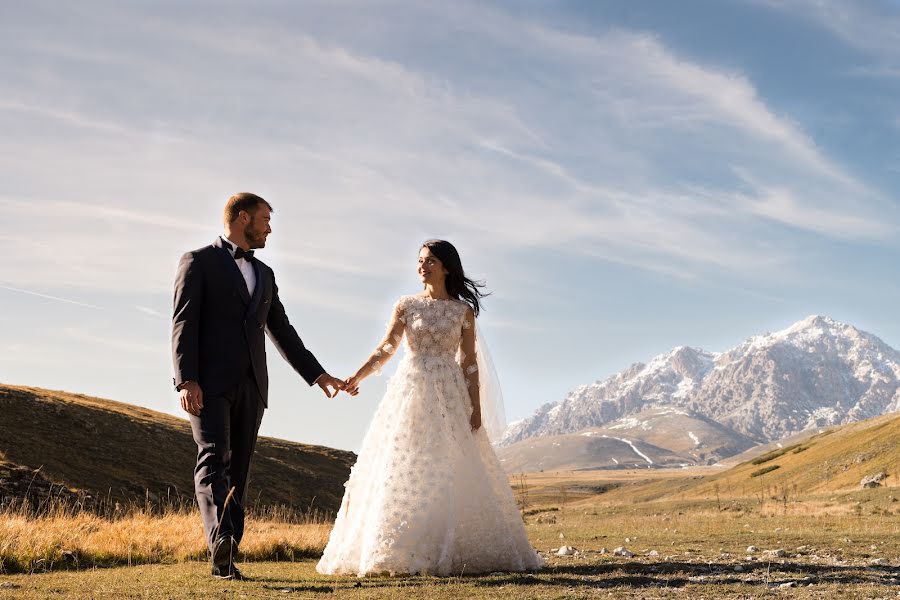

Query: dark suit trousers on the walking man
[[191, 371, 265, 552]]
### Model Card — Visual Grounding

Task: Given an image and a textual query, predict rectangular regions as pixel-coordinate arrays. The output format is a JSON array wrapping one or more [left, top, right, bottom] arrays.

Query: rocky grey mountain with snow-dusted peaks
[[502, 316, 900, 445]]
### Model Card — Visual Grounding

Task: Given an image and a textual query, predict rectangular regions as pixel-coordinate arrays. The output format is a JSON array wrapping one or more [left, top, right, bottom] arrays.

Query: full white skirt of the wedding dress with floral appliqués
[[316, 354, 543, 576]]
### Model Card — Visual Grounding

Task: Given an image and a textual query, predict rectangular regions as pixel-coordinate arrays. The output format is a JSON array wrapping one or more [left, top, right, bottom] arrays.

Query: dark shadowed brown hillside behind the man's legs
[[0, 385, 355, 511]]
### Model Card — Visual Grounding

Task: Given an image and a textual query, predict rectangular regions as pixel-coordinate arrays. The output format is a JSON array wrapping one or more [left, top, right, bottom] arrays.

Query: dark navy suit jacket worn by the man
[[172, 237, 325, 406]]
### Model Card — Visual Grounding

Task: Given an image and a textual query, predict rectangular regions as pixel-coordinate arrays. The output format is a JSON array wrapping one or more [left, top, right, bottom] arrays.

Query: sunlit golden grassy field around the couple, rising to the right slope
[[8, 400, 900, 600]]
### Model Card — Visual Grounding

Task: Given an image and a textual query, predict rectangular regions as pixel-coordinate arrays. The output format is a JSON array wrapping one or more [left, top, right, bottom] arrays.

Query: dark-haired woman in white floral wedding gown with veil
[[316, 240, 543, 577]]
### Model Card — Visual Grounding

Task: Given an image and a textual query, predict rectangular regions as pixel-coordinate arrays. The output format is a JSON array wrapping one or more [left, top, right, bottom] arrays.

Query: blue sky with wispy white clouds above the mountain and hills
[[0, 0, 900, 449]]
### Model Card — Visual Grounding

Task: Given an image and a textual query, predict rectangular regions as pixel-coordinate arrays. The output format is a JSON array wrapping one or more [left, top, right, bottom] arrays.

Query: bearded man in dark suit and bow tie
[[172, 193, 345, 579]]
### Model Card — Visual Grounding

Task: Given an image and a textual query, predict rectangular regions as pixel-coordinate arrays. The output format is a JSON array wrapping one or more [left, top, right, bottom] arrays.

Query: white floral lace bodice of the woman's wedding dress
[[396, 296, 472, 360]]
